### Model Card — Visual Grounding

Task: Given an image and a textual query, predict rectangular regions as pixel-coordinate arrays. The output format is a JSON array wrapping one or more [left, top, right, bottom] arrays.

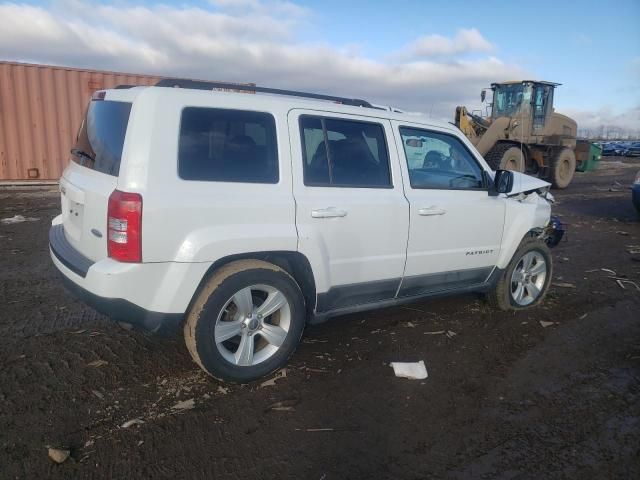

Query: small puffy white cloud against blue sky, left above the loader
[[408, 28, 494, 57]]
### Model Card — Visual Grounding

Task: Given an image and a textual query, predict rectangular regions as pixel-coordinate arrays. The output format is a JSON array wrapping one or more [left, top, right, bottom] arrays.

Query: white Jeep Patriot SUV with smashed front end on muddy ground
[[49, 80, 562, 382]]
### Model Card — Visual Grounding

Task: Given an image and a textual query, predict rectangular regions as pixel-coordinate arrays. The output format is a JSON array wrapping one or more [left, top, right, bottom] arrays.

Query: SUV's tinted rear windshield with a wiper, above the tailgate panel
[[71, 100, 131, 177]]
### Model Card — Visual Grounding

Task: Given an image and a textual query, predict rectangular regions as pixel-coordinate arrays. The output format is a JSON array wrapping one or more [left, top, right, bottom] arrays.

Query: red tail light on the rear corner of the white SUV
[[107, 190, 142, 263]]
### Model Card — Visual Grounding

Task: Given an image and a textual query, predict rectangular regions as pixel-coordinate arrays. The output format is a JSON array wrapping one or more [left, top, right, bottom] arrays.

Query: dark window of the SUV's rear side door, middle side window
[[300, 115, 391, 188]]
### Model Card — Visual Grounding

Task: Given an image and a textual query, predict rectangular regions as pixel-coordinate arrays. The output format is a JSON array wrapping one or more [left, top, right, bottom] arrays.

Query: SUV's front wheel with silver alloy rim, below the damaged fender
[[487, 237, 553, 310]]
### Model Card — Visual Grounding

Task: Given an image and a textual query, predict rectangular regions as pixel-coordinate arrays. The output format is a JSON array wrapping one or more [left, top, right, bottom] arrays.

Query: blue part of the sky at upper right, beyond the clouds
[[300, 0, 640, 115]]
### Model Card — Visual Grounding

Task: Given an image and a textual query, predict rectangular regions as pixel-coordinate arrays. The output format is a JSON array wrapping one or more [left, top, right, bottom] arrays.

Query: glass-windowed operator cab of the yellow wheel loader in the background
[[491, 80, 559, 133]]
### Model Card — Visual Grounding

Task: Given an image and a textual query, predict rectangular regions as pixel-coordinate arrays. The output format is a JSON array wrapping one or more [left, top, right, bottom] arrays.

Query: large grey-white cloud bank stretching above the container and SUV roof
[[0, 0, 527, 120]]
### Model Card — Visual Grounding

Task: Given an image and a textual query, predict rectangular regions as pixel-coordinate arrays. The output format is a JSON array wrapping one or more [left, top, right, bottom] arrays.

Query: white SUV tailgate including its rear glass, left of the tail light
[[60, 94, 131, 261]]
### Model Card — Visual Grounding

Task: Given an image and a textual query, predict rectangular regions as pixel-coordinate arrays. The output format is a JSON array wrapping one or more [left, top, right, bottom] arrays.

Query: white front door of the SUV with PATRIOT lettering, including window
[[394, 122, 505, 297]]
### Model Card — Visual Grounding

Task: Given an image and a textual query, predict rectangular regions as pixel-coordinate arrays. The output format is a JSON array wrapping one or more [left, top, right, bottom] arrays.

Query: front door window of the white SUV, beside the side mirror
[[400, 127, 483, 190]]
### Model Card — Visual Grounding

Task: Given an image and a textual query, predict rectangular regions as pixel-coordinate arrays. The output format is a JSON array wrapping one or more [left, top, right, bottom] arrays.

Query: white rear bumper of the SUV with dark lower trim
[[49, 222, 209, 334]]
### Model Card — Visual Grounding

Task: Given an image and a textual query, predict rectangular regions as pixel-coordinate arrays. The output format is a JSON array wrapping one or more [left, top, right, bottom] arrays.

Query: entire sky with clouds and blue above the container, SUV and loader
[[0, 0, 640, 129]]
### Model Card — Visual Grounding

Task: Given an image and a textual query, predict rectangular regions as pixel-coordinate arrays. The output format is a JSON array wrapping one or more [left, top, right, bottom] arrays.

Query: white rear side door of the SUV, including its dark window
[[289, 110, 409, 312]]
